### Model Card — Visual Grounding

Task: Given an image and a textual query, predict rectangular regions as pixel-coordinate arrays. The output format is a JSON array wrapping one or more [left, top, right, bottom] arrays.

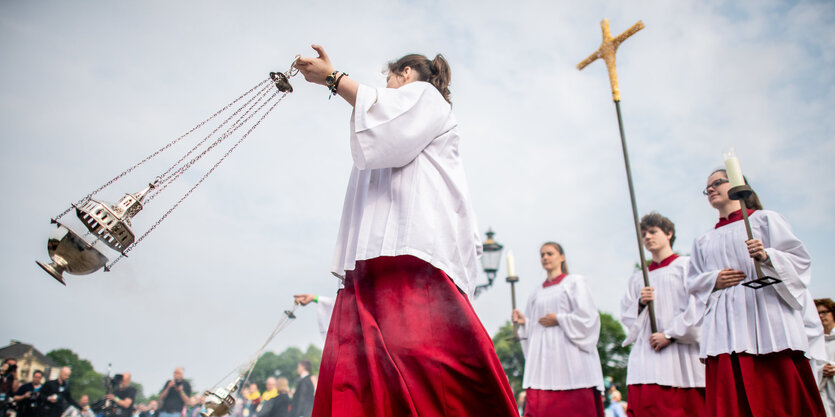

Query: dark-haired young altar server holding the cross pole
[[620, 212, 705, 417]]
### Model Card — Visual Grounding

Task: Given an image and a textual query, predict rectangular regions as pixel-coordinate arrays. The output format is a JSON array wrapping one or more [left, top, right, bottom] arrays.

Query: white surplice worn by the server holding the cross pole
[[620, 256, 705, 388]]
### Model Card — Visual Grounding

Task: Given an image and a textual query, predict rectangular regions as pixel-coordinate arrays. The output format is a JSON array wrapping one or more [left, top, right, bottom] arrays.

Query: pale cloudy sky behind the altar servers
[[0, 0, 835, 395]]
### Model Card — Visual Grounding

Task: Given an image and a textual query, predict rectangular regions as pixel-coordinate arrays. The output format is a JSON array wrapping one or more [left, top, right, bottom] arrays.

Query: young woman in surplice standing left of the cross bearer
[[513, 242, 604, 417]]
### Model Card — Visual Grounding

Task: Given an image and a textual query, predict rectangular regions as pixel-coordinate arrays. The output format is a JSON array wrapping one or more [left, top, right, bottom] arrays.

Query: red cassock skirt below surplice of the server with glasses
[[708, 350, 826, 417]]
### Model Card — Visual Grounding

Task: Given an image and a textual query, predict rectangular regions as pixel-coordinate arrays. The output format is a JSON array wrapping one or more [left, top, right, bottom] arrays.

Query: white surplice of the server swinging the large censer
[[331, 81, 481, 297]]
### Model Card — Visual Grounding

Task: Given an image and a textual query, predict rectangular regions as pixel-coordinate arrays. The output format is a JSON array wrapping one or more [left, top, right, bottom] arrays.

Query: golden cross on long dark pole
[[577, 19, 658, 333]]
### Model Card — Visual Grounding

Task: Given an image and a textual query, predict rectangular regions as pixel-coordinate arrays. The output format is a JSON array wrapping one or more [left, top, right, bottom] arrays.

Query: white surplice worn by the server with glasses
[[687, 210, 825, 359]]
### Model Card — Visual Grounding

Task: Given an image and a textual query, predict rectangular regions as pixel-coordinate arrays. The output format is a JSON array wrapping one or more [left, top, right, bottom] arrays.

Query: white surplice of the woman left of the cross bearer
[[519, 275, 603, 392]]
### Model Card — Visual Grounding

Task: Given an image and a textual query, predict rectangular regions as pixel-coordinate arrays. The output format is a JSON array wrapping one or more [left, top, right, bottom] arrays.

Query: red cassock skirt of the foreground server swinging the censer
[[313, 256, 518, 417]]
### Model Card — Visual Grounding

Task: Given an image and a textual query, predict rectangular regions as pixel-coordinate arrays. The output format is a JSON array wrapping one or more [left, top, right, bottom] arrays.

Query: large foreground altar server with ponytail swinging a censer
[[295, 45, 517, 416]]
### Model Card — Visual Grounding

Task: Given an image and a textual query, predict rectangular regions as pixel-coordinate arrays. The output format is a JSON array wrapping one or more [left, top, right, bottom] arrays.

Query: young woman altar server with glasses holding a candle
[[687, 170, 825, 417]]
